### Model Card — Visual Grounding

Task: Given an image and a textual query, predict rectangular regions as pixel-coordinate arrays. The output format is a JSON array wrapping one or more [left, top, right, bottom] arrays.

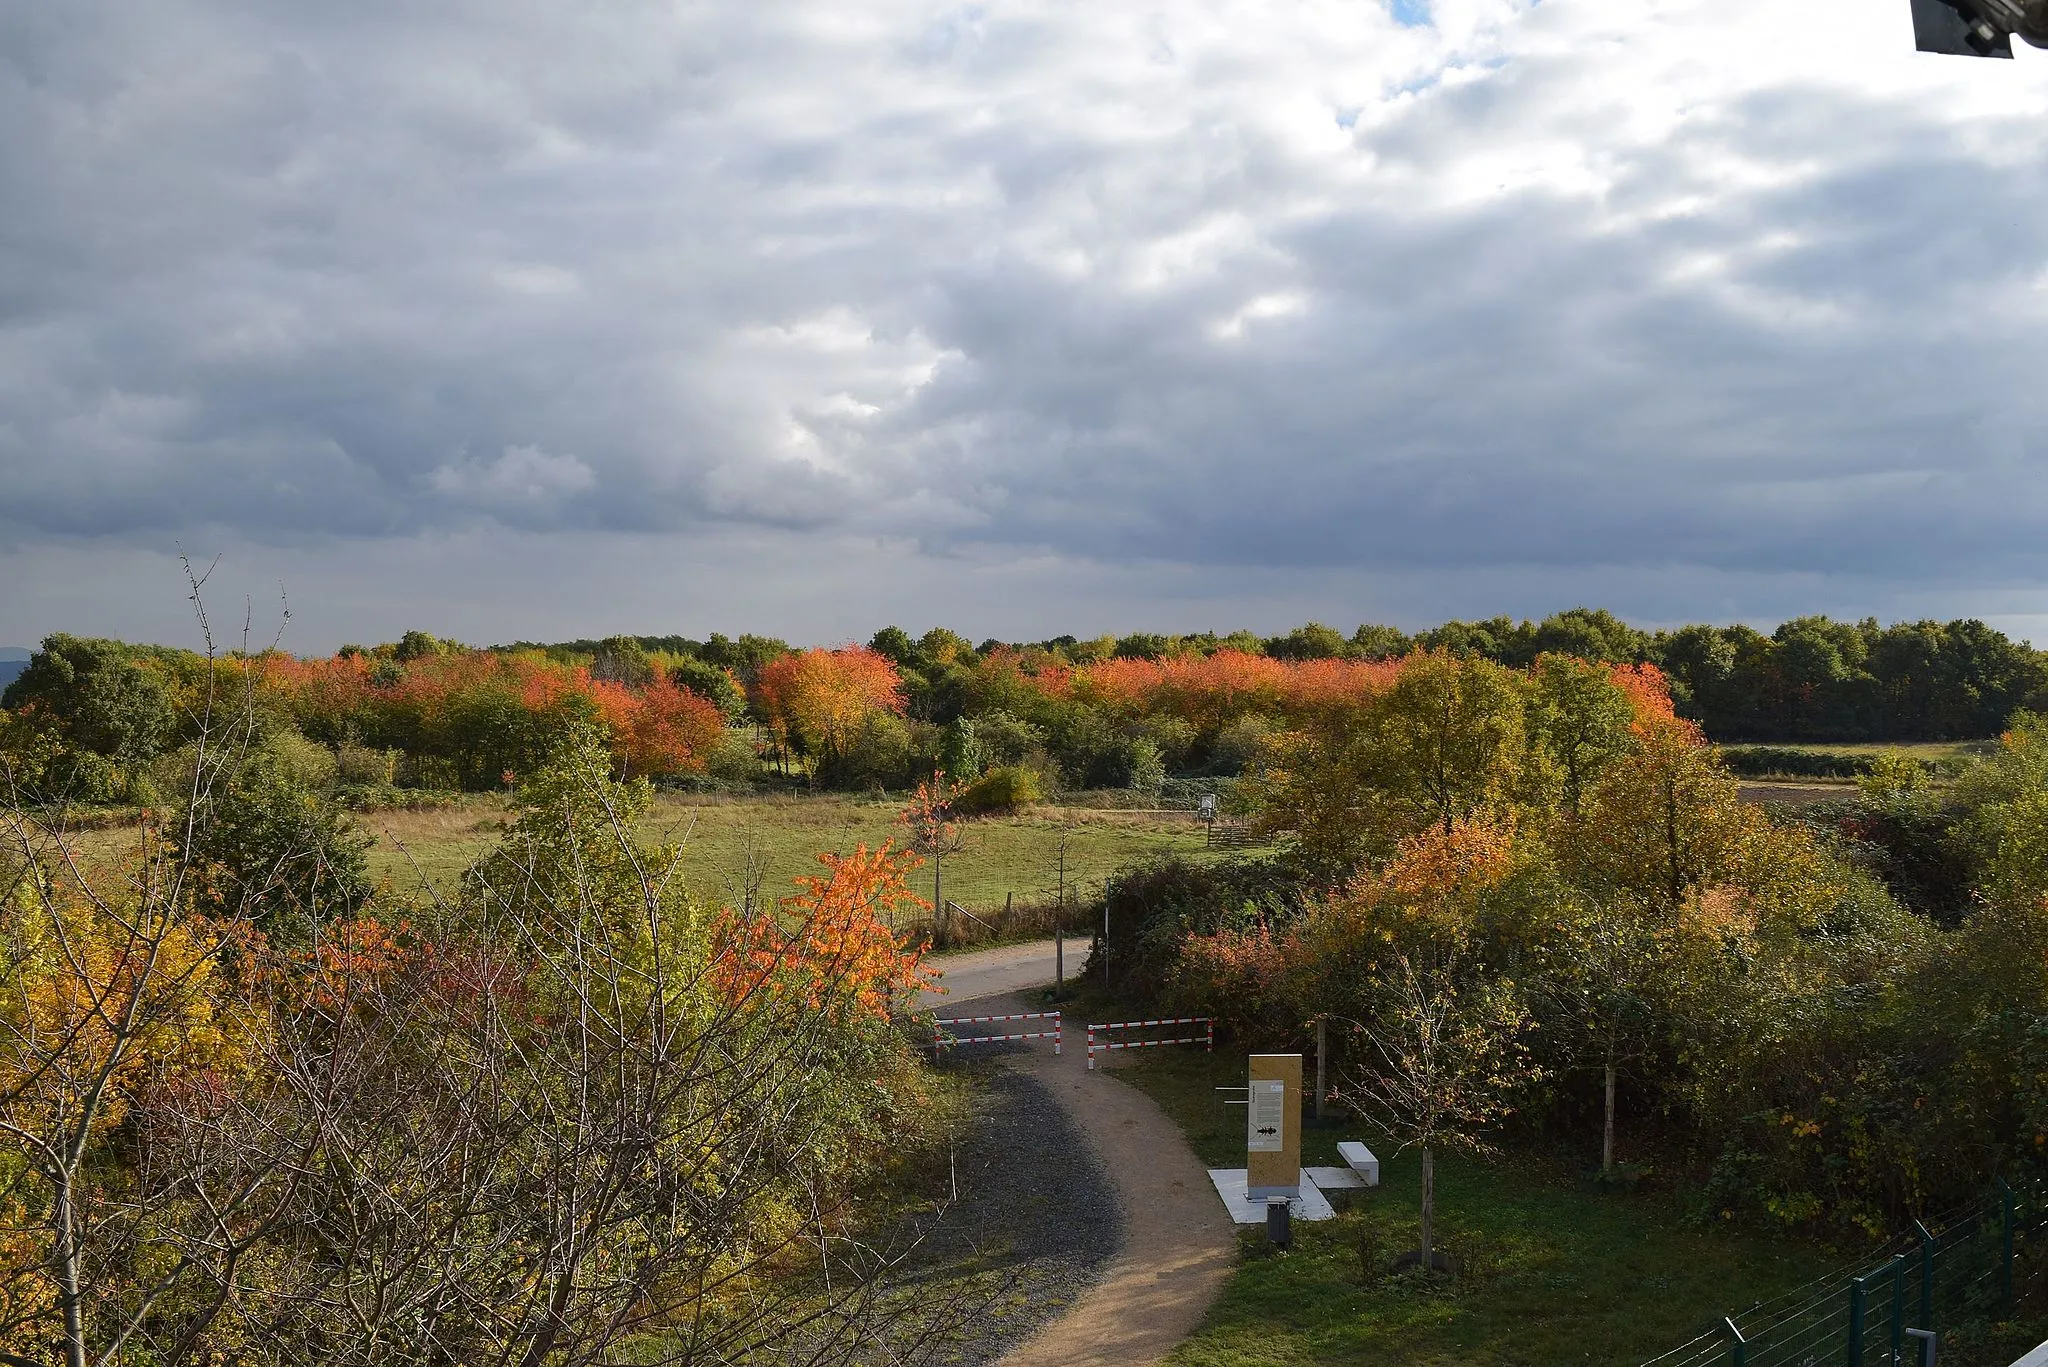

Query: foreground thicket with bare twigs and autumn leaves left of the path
[[0, 728, 942, 1367]]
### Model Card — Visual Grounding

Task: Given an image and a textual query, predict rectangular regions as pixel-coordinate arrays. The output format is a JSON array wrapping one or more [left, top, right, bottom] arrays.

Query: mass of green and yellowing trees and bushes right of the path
[[1102, 656, 2048, 1232]]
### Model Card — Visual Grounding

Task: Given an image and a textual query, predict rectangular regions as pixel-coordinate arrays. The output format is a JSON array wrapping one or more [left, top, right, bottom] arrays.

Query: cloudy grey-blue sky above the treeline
[[0, 0, 2048, 652]]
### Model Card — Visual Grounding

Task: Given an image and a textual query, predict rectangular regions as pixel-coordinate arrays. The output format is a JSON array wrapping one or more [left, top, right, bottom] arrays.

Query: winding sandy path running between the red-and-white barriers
[[928, 941, 1237, 1367]]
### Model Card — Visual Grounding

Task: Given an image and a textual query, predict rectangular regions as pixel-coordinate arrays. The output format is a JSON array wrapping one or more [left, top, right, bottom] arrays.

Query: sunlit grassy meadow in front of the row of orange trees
[[360, 795, 1236, 910]]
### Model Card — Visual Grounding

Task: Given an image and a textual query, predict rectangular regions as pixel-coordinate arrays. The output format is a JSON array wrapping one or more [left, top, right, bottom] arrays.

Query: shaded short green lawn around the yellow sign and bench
[[1118, 1049, 1841, 1367]]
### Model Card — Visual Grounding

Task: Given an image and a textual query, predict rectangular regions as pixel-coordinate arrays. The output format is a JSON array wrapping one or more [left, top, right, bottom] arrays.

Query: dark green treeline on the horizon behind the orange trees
[[524, 609, 2048, 744]]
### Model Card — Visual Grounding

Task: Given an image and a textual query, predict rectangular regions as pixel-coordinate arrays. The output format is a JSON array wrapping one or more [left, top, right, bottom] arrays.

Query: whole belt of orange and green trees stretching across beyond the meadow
[[0, 609, 2048, 805]]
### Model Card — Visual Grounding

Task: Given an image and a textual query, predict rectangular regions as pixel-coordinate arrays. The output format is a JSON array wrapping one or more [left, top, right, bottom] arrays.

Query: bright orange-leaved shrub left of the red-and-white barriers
[[715, 842, 936, 1019]]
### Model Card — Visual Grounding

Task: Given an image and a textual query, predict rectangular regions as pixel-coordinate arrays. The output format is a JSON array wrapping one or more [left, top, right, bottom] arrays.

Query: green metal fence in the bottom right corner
[[1642, 1180, 2048, 1367]]
